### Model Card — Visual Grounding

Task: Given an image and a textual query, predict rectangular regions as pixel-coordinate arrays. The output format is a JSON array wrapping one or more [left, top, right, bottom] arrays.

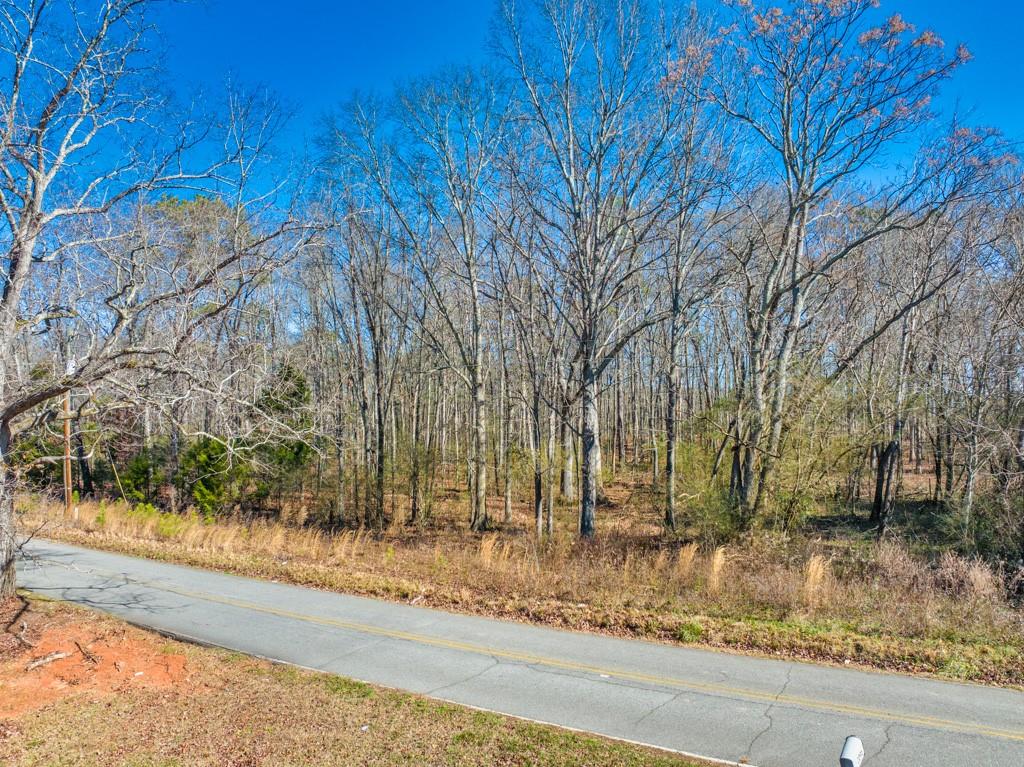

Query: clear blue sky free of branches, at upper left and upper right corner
[[158, 0, 1024, 151]]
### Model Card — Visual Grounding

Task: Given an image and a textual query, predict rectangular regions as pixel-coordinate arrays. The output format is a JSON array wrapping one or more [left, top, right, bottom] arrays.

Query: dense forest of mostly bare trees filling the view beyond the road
[[0, 0, 1024, 678]]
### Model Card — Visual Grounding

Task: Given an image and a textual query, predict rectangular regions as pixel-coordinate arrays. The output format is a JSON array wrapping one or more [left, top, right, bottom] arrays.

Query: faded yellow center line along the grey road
[[138, 582, 1024, 741]]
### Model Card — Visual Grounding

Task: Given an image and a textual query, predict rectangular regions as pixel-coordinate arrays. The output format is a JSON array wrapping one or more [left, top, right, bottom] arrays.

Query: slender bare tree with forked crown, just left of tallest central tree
[[338, 72, 506, 529]]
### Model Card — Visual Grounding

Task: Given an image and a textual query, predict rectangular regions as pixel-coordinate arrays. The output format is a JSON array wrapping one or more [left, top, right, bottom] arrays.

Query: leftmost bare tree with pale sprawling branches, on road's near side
[[0, 0, 311, 596]]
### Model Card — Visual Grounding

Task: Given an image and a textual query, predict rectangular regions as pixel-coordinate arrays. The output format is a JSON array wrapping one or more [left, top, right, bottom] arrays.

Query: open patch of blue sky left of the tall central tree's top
[[157, 0, 495, 148]]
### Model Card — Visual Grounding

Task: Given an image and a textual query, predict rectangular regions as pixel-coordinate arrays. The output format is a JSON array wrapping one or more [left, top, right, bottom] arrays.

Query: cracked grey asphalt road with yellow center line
[[18, 541, 1024, 767]]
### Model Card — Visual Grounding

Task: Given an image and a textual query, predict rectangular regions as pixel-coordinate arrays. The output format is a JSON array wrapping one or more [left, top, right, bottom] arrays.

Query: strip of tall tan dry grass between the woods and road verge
[[19, 491, 1024, 642]]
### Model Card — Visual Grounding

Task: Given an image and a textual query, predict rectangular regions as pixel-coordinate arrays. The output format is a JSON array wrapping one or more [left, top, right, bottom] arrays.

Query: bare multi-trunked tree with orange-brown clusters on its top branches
[[690, 0, 1007, 519]]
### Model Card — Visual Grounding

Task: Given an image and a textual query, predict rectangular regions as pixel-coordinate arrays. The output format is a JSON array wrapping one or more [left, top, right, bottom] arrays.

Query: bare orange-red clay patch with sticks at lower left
[[0, 598, 187, 724]]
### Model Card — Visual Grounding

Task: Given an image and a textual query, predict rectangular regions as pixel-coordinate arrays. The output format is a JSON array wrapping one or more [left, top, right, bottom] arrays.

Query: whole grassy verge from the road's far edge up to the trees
[[18, 484, 1024, 687]]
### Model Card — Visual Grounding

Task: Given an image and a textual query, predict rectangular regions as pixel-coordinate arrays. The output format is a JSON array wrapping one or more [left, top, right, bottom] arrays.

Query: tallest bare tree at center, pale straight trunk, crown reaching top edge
[[502, 0, 692, 538]]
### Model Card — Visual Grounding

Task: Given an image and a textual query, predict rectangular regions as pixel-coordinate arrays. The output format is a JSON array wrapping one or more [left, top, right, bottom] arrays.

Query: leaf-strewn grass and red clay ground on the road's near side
[[0, 598, 696, 767]]
